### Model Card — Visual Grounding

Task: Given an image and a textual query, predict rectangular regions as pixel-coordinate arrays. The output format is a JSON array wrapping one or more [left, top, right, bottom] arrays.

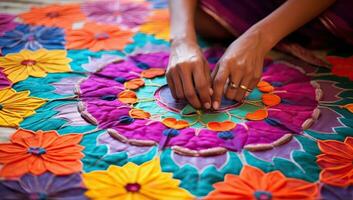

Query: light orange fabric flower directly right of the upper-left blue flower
[[66, 23, 133, 51]]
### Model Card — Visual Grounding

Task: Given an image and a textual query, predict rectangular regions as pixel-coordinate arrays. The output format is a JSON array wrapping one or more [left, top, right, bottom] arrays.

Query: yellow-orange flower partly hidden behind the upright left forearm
[[140, 9, 170, 40]]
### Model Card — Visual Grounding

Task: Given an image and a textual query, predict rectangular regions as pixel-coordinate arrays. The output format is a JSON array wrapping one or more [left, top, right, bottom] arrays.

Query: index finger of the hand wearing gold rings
[[212, 63, 229, 110]]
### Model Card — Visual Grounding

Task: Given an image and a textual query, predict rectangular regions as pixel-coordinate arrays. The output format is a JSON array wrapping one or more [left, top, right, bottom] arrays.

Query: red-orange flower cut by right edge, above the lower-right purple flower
[[317, 137, 353, 187]]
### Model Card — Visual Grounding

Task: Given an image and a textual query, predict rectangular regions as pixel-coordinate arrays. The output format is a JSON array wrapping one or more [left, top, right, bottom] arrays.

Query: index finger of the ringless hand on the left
[[193, 63, 211, 109]]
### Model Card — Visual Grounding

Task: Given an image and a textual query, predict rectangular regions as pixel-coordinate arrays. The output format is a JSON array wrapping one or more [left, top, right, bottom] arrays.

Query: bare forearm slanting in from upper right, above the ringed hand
[[250, 0, 335, 50]]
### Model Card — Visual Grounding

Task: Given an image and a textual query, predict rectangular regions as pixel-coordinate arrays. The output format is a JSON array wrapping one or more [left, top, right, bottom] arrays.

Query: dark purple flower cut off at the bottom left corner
[[0, 172, 87, 200]]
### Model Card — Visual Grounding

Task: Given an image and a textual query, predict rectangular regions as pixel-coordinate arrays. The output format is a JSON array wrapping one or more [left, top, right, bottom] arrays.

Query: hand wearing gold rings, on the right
[[212, 29, 271, 110]]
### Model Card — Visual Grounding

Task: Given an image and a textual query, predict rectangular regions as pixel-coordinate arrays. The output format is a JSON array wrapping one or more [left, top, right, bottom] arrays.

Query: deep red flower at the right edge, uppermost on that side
[[326, 56, 353, 80]]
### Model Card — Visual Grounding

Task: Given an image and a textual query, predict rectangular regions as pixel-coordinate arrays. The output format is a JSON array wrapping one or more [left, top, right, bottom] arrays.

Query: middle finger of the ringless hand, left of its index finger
[[177, 64, 201, 108]]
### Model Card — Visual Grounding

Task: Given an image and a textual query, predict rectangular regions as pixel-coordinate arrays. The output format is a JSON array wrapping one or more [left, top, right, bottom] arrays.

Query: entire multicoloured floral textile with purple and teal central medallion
[[0, 0, 353, 200]]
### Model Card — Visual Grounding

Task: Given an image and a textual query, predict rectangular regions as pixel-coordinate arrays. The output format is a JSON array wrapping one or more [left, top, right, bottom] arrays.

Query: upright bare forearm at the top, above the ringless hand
[[169, 0, 197, 41]]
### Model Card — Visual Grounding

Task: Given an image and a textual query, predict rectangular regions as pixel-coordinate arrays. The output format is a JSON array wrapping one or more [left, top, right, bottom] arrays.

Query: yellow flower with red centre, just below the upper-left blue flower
[[0, 49, 71, 83]]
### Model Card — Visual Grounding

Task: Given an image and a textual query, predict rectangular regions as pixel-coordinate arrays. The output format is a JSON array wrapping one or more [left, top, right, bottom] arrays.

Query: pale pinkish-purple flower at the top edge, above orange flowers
[[82, 0, 149, 28]]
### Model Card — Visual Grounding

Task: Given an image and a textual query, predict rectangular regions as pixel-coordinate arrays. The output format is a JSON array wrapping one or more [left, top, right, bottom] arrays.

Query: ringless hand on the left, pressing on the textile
[[166, 39, 212, 109]]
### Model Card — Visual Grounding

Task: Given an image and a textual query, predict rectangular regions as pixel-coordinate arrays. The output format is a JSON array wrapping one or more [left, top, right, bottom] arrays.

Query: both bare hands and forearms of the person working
[[166, 0, 335, 110]]
